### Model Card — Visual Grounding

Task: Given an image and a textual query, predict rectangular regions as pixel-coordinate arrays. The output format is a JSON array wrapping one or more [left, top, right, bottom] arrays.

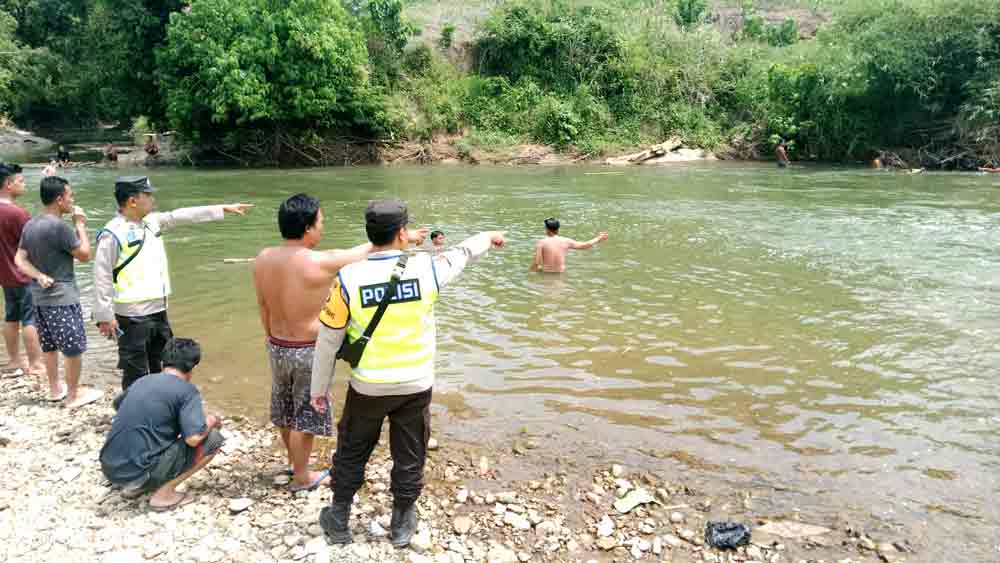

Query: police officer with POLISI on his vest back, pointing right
[[311, 201, 504, 547]]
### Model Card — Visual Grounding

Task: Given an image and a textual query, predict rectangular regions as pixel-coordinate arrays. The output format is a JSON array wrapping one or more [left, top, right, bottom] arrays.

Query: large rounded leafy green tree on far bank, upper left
[[157, 0, 378, 154]]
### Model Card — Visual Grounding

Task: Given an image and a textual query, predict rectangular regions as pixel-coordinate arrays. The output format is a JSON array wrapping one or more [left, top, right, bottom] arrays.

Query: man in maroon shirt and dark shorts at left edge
[[0, 164, 45, 376]]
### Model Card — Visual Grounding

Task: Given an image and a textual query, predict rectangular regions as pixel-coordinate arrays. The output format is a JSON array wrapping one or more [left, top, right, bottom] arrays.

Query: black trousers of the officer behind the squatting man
[[115, 311, 174, 390]]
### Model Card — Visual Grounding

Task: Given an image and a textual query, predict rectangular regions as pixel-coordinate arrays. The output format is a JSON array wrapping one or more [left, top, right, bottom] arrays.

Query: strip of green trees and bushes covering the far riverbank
[[0, 0, 1000, 167]]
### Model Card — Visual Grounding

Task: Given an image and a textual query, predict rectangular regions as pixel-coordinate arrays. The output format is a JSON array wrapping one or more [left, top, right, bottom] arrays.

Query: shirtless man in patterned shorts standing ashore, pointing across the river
[[253, 194, 426, 492]]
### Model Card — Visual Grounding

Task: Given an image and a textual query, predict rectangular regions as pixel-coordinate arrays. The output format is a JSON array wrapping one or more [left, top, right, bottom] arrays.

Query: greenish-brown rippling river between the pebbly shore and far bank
[[1, 163, 1000, 561]]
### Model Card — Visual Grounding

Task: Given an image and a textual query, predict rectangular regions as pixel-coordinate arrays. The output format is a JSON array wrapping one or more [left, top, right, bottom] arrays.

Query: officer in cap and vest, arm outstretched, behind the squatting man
[[94, 176, 253, 390]]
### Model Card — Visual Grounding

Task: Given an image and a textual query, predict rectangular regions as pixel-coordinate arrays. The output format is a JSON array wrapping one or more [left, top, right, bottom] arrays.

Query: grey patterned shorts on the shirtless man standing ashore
[[267, 339, 333, 436]]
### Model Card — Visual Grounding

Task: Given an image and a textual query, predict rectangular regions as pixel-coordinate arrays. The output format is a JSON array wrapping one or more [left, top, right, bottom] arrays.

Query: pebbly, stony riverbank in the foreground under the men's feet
[[0, 352, 919, 563]]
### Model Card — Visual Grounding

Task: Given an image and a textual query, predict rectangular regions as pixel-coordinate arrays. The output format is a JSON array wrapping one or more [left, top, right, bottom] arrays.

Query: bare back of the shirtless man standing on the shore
[[253, 246, 335, 342]]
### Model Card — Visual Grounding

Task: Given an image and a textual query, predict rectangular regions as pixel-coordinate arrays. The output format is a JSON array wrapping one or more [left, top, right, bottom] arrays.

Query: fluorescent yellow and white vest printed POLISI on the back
[[339, 254, 438, 384]]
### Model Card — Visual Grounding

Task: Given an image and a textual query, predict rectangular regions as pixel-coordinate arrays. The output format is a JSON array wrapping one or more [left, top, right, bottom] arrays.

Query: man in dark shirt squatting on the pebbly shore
[[101, 338, 223, 512]]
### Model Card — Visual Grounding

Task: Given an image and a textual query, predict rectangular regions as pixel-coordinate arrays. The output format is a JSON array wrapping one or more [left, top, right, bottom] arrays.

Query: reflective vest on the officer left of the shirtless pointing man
[[97, 215, 170, 303]]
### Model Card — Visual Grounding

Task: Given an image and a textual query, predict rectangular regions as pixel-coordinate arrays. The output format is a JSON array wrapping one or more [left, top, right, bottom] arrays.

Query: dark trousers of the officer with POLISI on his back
[[333, 386, 432, 507]]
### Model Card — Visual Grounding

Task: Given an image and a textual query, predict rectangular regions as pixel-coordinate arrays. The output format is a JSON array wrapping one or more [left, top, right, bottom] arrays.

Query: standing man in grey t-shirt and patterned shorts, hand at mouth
[[14, 176, 104, 408]]
